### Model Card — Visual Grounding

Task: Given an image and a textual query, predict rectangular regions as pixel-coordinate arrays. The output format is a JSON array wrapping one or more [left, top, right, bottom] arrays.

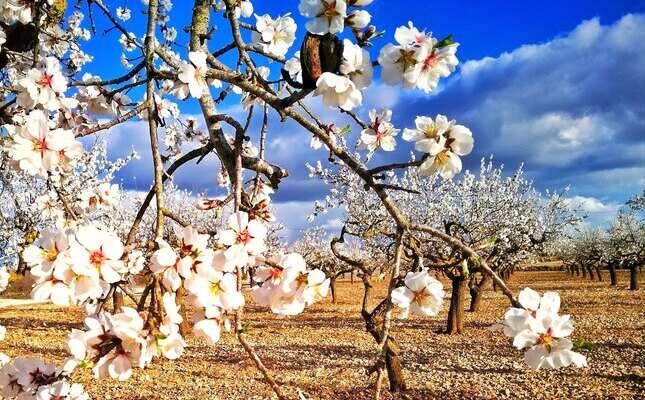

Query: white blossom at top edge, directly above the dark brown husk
[[298, 0, 347, 35]]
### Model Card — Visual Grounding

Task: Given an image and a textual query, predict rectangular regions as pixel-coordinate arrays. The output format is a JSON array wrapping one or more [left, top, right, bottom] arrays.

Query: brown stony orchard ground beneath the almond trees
[[0, 271, 645, 400]]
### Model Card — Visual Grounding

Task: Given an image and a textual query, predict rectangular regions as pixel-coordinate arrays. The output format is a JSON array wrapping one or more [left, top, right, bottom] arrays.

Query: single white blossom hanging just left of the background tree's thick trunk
[[392, 269, 444, 318]]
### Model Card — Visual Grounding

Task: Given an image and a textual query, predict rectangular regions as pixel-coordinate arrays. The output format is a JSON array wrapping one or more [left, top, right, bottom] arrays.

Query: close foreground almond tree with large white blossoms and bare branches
[[0, 0, 584, 399]]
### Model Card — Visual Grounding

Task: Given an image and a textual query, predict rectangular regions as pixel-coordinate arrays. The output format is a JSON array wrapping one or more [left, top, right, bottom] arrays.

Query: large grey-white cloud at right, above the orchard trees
[[405, 15, 645, 201]]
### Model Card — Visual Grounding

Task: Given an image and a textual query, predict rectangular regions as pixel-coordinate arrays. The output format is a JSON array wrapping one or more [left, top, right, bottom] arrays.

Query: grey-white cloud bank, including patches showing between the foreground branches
[[98, 15, 645, 236]]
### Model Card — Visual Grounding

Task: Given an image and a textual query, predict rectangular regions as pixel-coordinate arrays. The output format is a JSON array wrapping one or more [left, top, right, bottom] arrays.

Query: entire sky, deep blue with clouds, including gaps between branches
[[79, 0, 645, 238]]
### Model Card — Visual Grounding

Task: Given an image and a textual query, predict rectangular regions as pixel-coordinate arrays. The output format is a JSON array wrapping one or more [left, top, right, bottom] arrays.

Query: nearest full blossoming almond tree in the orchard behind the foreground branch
[[313, 156, 579, 333]]
